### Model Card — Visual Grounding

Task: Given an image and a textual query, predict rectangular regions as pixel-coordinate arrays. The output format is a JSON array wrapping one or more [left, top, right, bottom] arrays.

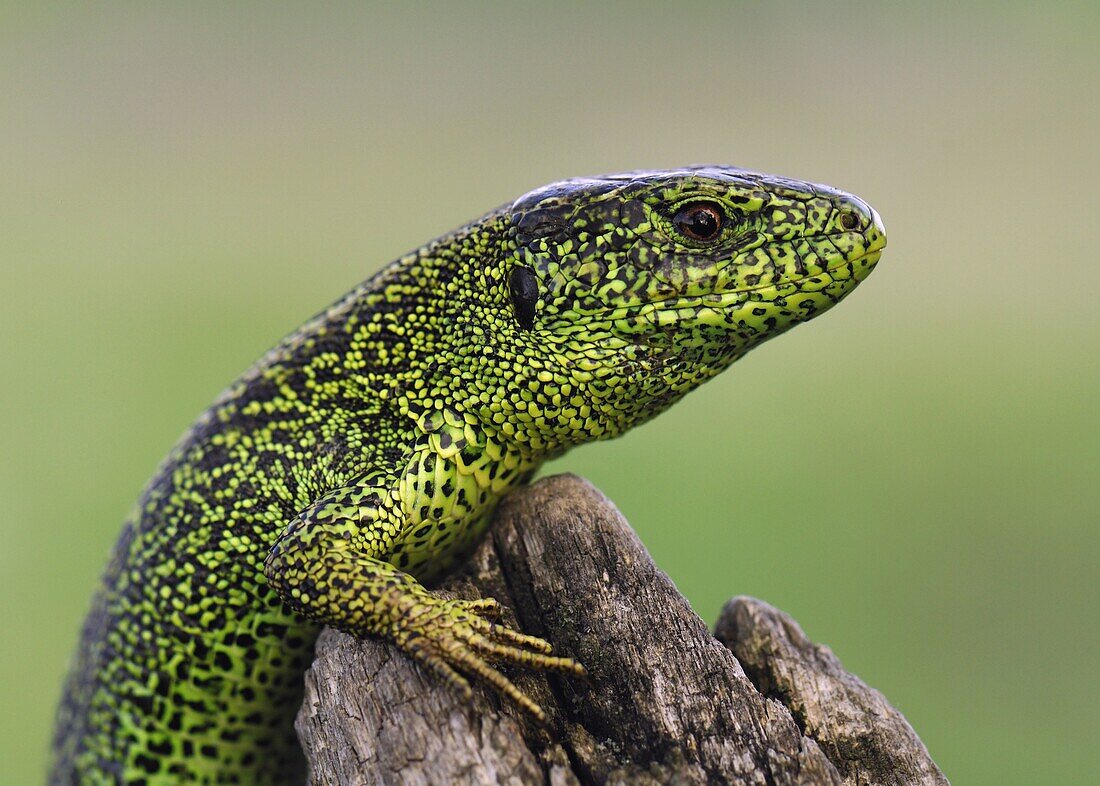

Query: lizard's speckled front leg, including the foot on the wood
[[264, 475, 584, 720]]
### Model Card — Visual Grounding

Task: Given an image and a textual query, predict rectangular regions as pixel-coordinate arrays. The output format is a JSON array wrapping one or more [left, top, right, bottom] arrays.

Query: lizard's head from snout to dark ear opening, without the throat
[[509, 167, 886, 355]]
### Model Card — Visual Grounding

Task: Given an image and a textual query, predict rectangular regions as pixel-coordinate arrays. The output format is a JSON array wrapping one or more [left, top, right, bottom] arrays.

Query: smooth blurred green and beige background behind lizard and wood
[[0, 3, 1100, 784]]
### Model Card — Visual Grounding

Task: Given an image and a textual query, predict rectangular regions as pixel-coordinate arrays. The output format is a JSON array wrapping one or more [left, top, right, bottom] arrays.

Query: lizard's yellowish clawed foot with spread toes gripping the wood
[[394, 595, 585, 722]]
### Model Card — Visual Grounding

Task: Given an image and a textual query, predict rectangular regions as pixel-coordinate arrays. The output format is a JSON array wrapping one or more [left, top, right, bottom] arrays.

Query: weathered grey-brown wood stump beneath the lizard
[[297, 475, 947, 786]]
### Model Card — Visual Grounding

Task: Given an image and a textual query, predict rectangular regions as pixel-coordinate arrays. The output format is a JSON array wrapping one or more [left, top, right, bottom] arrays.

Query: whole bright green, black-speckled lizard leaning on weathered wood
[[51, 167, 886, 785]]
